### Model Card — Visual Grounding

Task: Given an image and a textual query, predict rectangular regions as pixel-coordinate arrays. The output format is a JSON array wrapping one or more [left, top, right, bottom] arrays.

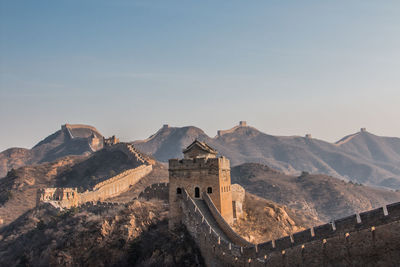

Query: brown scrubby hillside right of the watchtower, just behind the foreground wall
[[231, 163, 400, 222]]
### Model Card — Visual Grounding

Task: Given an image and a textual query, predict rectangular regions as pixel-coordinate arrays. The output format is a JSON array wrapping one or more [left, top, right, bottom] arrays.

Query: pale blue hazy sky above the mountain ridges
[[0, 0, 400, 150]]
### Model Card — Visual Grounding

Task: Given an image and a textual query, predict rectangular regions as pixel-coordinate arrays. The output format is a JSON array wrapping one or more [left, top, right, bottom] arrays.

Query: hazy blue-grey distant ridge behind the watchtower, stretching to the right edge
[[134, 123, 400, 189]]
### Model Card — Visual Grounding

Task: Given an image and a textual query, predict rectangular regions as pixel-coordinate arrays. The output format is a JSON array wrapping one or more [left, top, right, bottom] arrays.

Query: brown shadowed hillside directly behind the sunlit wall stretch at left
[[0, 149, 153, 228]]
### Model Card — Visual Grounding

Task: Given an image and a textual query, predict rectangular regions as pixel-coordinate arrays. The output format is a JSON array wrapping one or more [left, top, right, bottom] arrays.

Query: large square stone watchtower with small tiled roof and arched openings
[[169, 140, 233, 229]]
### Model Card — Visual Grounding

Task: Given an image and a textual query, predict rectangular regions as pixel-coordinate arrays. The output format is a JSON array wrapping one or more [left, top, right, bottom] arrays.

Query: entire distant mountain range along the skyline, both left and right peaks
[[0, 122, 400, 190]]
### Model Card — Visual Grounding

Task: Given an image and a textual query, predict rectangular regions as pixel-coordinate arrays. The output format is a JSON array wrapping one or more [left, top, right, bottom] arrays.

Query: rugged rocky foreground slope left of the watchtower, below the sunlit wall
[[0, 200, 203, 266]]
